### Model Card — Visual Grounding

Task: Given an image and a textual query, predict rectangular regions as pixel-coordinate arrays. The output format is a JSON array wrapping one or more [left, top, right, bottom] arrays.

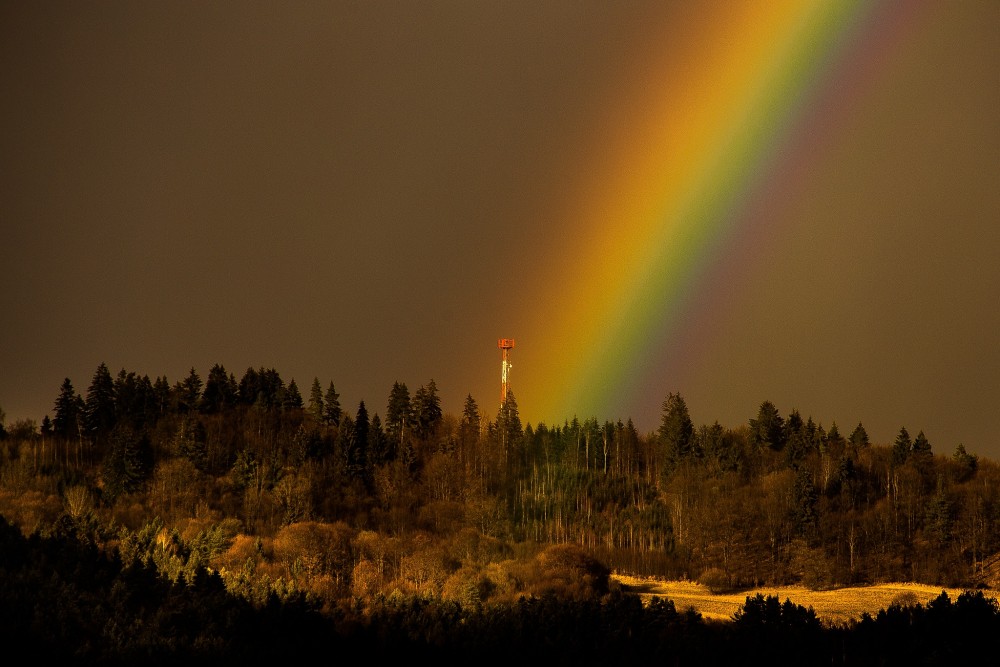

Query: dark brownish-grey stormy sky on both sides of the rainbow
[[0, 1, 1000, 457]]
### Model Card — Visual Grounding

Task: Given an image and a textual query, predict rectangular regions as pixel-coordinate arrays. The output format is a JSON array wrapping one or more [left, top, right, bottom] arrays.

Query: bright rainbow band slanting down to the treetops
[[515, 0, 927, 428]]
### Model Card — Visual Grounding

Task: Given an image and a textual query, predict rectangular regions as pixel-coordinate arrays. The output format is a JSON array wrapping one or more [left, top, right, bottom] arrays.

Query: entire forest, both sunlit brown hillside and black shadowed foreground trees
[[0, 363, 1000, 664]]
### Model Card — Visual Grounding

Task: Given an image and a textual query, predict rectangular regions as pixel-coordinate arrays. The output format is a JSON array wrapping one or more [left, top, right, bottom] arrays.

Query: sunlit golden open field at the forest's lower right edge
[[612, 574, 1000, 624]]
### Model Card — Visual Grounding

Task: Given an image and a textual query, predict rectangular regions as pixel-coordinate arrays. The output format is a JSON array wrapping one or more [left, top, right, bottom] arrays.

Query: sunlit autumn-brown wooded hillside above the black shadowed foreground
[[0, 363, 1000, 664]]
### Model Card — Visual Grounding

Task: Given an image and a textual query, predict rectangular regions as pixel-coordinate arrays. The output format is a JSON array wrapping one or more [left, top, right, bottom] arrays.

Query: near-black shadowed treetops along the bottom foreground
[[0, 519, 1000, 665]]
